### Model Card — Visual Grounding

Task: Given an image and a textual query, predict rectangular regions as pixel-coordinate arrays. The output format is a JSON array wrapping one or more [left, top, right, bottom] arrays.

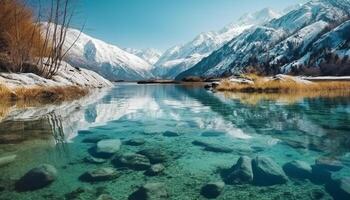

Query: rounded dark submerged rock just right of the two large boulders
[[283, 160, 312, 179]]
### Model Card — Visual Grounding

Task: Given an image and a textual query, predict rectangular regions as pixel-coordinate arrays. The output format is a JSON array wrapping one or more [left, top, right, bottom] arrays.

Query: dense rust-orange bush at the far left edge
[[0, 0, 46, 72]]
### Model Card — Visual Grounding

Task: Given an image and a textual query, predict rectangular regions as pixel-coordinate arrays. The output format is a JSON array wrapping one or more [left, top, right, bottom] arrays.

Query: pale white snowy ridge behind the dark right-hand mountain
[[152, 8, 280, 78]]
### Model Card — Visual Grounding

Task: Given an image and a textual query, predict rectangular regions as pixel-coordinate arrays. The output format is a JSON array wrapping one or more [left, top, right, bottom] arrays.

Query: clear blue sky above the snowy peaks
[[78, 0, 305, 51]]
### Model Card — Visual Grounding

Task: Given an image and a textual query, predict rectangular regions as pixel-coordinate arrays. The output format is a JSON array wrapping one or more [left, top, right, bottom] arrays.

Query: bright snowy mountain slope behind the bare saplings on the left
[[55, 24, 152, 80]]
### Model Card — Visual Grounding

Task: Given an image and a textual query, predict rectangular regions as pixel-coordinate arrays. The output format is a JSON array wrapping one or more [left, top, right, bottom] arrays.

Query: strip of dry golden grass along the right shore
[[216, 76, 350, 93]]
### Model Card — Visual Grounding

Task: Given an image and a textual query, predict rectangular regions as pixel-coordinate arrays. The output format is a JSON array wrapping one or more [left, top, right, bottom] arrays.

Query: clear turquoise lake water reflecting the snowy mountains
[[0, 84, 350, 200]]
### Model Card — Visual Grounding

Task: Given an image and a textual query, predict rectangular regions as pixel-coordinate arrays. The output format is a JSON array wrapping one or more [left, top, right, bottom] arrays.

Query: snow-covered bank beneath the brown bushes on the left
[[0, 62, 113, 88]]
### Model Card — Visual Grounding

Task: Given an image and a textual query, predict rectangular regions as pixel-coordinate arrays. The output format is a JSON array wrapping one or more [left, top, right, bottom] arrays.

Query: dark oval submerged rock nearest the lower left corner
[[16, 164, 57, 191]]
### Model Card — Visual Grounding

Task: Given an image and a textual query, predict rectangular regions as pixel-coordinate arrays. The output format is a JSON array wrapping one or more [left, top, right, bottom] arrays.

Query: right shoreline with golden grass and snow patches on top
[[212, 74, 350, 94]]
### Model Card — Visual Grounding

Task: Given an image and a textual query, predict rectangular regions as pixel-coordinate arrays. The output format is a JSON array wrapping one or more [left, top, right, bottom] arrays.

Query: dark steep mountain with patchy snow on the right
[[177, 0, 350, 79]]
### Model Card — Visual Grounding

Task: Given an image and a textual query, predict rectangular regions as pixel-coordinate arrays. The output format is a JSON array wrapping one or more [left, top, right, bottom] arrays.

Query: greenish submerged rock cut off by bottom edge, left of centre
[[129, 183, 169, 200]]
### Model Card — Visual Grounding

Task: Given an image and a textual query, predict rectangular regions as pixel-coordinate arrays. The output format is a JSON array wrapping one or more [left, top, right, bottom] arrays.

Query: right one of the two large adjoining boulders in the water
[[252, 156, 288, 186]]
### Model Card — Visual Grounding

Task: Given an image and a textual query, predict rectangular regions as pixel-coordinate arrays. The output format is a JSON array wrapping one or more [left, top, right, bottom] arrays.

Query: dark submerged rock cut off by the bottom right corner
[[326, 177, 350, 200]]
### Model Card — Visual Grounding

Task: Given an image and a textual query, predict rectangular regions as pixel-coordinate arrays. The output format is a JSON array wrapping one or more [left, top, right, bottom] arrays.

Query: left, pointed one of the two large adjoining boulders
[[225, 156, 253, 184]]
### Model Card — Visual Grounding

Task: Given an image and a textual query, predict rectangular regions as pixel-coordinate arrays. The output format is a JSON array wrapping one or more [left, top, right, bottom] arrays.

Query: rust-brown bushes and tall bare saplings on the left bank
[[0, 0, 80, 79]]
